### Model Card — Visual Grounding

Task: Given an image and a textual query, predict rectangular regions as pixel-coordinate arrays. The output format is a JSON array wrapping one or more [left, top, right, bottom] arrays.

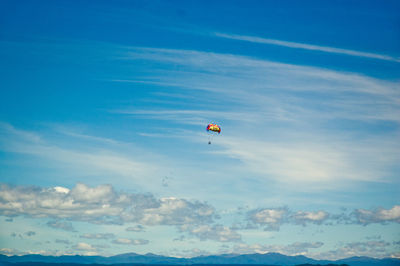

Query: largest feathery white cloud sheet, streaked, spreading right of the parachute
[[117, 47, 400, 189]]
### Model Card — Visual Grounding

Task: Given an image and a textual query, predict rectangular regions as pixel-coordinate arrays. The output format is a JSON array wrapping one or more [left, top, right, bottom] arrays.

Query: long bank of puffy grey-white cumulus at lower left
[[0, 183, 240, 242]]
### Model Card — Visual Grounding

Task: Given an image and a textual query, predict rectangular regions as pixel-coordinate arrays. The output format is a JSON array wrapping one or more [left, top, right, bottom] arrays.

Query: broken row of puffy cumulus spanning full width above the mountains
[[0, 183, 400, 231]]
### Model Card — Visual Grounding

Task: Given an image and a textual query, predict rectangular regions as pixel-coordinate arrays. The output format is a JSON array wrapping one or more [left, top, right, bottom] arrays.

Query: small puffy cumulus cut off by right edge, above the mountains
[[352, 205, 400, 225]]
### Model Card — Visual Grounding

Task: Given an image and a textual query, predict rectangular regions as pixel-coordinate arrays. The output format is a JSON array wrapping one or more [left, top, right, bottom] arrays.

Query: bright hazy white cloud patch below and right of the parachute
[[215, 132, 398, 185]]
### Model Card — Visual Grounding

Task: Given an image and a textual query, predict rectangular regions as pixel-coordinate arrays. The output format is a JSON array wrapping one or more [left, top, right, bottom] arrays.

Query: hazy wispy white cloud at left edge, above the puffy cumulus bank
[[0, 122, 166, 191]]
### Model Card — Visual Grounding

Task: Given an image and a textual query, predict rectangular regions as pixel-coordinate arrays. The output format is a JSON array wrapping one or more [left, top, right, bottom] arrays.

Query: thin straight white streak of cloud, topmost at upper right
[[213, 32, 400, 62]]
